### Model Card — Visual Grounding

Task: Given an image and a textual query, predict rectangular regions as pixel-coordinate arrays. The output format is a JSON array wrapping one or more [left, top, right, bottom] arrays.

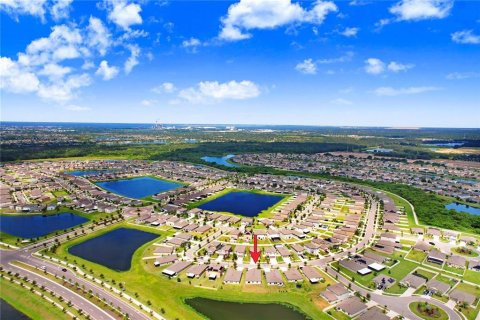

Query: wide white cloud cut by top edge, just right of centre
[[219, 0, 338, 41]]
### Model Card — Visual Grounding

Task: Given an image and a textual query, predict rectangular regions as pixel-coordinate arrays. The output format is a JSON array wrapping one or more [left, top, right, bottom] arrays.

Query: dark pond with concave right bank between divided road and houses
[[68, 228, 159, 271]]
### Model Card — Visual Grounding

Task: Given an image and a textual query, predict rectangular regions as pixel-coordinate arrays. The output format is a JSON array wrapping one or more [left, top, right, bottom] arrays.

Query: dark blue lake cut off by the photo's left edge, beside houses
[[0, 212, 88, 238]]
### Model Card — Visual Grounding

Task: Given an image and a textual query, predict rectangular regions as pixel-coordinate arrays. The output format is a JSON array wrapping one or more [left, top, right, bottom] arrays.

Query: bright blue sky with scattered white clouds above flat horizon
[[0, 0, 480, 127]]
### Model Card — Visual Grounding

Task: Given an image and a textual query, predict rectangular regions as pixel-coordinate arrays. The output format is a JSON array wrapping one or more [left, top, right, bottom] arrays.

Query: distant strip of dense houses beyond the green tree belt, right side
[[235, 150, 480, 203]]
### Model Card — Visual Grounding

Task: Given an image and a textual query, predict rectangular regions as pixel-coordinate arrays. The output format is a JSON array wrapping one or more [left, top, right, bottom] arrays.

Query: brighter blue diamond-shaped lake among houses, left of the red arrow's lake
[[96, 177, 182, 199]]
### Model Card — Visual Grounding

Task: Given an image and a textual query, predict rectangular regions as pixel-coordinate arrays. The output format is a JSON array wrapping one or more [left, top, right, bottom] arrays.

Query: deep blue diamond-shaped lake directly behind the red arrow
[[198, 191, 284, 217]]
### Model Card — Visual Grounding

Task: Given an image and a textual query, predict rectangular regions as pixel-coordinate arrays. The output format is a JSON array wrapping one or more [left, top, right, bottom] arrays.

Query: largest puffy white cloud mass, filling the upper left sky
[[0, 11, 142, 105]]
